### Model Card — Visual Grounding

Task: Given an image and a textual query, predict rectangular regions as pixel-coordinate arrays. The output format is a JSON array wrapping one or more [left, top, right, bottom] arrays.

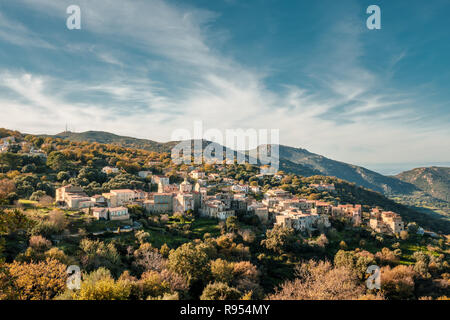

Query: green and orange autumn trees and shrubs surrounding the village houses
[[0, 130, 450, 300]]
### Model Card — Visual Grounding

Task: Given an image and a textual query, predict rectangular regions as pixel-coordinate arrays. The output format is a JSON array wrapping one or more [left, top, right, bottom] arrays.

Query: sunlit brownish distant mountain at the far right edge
[[395, 167, 450, 202]]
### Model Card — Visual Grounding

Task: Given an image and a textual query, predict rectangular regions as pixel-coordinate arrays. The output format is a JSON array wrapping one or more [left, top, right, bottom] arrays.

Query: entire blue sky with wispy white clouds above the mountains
[[0, 0, 450, 167]]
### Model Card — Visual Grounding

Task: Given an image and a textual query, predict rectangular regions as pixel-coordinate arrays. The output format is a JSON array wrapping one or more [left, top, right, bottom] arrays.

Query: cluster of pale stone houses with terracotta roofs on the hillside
[[56, 167, 404, 233]]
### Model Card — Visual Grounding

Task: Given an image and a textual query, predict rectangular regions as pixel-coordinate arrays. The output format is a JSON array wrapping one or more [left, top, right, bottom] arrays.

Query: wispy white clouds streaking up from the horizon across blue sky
[[0, 0, 450, 163]]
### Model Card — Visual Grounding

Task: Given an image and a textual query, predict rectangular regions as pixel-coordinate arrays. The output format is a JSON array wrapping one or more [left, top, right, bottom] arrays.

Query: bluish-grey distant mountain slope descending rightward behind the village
[[279, 145, 417, 194]]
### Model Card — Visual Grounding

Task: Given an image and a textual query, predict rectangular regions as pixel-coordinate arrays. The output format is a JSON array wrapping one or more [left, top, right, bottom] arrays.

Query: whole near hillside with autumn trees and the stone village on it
[[0, 129, 450, 300]]
